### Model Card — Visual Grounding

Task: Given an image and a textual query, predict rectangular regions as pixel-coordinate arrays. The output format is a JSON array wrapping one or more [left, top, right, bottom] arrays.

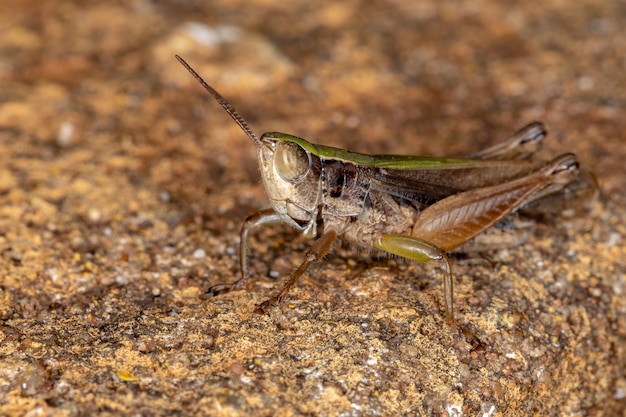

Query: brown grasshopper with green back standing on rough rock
[[176, 55, 596, 326]]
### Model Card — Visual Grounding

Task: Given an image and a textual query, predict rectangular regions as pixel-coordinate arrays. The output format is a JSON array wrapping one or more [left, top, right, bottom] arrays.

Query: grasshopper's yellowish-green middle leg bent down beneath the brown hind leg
[[374, 235, 454, 327]]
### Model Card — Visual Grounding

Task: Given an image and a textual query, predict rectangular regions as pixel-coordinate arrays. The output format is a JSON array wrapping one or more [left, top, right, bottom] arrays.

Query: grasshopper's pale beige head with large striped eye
[[258, 132, 321, 237]]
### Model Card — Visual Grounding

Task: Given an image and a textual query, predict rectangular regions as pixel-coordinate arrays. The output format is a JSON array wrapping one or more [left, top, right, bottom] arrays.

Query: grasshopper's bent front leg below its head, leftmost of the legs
[[204, 209, 282, 298]]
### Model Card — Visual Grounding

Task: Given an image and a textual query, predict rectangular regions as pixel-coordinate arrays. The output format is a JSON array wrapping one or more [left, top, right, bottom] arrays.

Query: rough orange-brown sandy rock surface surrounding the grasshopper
[[0, 0, 626, 416]]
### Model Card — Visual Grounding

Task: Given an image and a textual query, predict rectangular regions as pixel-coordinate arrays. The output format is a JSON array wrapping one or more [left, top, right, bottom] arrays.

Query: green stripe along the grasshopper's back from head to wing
[[263, 132, 489, 169]]
